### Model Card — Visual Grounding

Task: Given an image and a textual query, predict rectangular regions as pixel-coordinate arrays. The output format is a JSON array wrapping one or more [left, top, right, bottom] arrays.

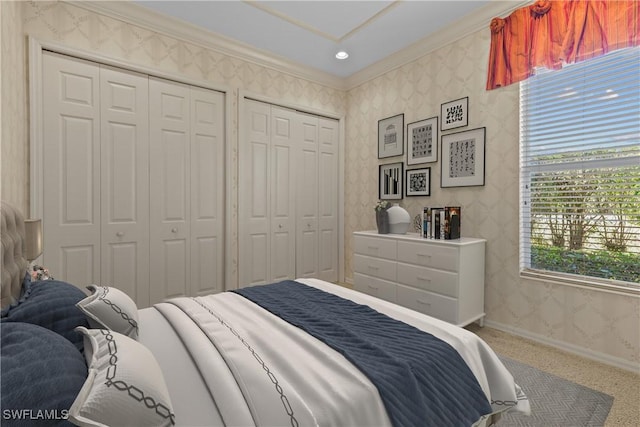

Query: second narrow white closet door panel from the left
[[100, 66, 149, 308]]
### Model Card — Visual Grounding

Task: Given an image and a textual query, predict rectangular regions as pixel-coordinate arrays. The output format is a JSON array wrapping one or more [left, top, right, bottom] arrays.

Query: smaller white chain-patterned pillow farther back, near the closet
[[77, 285, 138, 339]]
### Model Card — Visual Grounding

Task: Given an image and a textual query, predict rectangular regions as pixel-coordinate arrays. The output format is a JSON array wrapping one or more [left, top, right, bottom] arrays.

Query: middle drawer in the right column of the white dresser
[[397, 263, 458, 298]]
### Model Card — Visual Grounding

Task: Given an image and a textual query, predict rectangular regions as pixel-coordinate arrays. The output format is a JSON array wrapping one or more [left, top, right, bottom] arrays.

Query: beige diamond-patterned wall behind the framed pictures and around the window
[[345, 30, 640, 366]]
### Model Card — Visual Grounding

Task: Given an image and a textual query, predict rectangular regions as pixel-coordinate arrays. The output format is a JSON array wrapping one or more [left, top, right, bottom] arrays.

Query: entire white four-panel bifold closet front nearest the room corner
[[238, 100, 339, 286]]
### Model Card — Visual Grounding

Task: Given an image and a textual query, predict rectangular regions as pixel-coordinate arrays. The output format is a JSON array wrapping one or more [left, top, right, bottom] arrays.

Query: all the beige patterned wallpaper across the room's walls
[[1, 2, 640, 369]]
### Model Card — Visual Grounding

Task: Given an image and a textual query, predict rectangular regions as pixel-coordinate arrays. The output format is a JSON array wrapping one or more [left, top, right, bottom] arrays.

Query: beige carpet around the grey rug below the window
[[467, 324, 640, 427]]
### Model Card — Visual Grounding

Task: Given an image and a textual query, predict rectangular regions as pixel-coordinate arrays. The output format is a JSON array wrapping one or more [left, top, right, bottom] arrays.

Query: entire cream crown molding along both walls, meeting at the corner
[[69, 0, 531, 91]]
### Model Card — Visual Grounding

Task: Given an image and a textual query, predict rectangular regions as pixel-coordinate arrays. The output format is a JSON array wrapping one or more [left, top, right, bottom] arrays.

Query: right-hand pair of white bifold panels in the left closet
[[149, 77, 224, 304]]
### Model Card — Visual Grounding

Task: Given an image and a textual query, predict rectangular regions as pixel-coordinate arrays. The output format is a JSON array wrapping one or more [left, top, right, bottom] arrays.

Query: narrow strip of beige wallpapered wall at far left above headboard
[[0, 1, 29, 215]]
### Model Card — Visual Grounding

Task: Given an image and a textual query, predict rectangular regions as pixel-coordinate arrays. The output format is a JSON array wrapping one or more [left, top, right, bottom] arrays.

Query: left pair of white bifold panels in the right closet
[[238, 100, 298, 286]]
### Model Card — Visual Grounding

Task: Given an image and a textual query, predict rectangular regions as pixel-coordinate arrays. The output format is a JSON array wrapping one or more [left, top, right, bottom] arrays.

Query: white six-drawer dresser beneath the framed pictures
[[353, 231, 486, 326]]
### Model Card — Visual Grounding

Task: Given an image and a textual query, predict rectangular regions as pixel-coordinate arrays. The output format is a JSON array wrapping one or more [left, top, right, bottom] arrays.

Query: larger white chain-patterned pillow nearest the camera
[[69, 326, 175, 427]]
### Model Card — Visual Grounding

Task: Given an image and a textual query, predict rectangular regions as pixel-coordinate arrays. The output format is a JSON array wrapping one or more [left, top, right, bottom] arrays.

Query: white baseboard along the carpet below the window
[[484, 319, 640, 374]]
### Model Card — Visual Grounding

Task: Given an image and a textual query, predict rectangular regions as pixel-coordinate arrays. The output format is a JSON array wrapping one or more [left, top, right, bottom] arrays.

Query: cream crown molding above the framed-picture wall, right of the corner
[[345, 0, 531, 90]]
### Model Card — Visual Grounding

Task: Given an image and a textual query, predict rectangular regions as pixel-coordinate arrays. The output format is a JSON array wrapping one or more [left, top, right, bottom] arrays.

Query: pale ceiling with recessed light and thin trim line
[[135, 0, 491, 78]]
